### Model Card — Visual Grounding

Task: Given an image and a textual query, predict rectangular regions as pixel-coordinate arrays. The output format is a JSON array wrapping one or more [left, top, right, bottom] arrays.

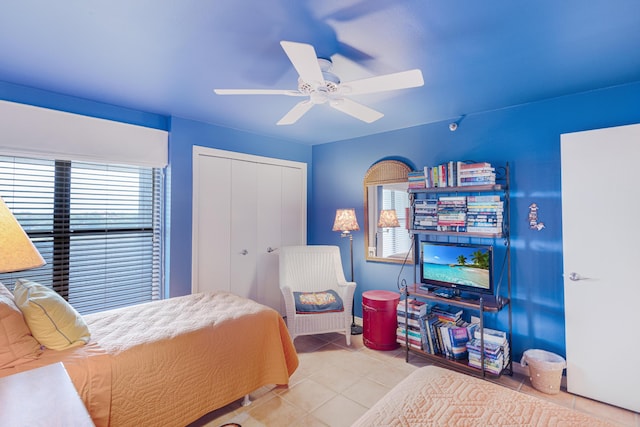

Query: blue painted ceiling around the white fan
[[0, 0, 640, 144]]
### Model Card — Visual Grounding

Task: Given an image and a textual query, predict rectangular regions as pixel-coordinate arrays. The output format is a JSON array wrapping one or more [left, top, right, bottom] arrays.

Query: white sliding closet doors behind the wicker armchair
[[192, 147, 307, 314]]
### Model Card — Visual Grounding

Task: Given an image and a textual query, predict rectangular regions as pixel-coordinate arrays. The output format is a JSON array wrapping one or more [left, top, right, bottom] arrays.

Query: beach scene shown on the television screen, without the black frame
[[422, 245, 490, 289]]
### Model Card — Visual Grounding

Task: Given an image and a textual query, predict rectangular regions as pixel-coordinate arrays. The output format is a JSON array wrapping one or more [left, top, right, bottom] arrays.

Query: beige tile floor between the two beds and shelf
[[190, 334, 640, 427]]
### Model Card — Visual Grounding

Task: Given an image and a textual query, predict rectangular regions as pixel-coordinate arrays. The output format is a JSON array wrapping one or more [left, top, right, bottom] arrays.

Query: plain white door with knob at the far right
[[561, 125, 640, 412]]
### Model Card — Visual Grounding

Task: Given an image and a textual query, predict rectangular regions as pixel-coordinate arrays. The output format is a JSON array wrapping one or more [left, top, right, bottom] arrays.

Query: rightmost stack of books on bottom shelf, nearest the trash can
[[467, 328, 510, 375]]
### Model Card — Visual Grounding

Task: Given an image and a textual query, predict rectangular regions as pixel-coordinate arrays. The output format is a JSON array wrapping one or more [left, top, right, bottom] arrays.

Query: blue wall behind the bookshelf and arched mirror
[[309, 80, 640, 362]]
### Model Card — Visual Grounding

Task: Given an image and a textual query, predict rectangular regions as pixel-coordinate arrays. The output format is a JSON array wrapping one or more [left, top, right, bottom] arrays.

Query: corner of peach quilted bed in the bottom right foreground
[[352, 366, 610, 427]]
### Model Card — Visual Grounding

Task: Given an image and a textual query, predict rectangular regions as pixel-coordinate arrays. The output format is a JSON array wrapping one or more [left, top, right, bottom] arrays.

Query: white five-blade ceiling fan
[[214, 41, 424, 125]]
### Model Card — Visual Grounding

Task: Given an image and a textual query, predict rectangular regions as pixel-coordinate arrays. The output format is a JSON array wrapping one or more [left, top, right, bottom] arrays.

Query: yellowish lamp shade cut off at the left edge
[[0, 198, 45, 273]]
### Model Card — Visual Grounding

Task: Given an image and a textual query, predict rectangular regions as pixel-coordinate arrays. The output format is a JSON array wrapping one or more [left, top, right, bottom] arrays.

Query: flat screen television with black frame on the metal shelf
[[420, 242, 494, 295]]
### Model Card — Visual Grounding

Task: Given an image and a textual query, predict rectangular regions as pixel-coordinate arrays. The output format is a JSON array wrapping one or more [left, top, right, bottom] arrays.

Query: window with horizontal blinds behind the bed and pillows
[[0, 156, 163, 314]]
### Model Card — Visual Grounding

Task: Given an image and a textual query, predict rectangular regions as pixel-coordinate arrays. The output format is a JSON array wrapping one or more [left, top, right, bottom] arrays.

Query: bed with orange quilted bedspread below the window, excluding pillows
[[0, 292, 298, 427]]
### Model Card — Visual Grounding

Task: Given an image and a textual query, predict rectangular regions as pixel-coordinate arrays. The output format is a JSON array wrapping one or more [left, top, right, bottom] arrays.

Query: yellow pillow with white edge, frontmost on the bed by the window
[[13, 279, 91, 350]]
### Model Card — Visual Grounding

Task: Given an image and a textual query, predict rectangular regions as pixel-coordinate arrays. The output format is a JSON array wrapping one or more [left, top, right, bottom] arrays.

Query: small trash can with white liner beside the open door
[[520, 349, 567, 394]]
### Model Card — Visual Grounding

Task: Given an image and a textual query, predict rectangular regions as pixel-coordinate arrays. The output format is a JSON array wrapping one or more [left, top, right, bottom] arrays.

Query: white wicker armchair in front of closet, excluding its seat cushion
[[280, 245, 356, 345]]
